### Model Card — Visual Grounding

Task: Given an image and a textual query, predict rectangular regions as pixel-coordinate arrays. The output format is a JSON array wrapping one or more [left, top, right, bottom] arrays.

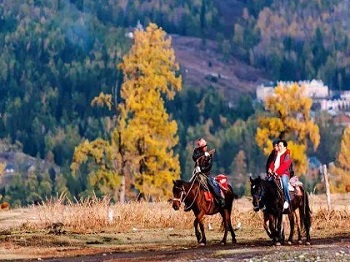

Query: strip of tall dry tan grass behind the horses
[[0, 194, 350, 236]]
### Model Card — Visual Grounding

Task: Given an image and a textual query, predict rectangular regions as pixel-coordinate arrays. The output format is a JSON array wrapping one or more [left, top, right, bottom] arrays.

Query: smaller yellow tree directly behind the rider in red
[[255, 83, 320, 174]]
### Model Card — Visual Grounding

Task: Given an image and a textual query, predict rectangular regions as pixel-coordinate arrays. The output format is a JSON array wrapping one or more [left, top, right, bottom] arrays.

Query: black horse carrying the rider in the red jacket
[[250, 177, 311, 245]]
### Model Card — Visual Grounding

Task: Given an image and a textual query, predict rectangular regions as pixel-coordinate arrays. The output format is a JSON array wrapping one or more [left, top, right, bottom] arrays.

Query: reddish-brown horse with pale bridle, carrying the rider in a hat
[[172, 173, 237, 245]]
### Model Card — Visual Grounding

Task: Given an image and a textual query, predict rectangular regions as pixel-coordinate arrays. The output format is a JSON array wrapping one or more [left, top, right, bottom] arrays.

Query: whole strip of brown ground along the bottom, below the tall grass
[[0, 228, 350, 262]]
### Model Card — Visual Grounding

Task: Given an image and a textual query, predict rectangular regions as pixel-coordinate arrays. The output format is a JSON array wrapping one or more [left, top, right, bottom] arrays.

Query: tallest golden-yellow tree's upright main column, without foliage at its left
[[118, 24, 181, 197]]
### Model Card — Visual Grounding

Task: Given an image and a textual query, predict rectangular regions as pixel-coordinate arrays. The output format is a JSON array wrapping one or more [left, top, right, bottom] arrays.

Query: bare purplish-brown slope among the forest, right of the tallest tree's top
[[171, 35, 268, 103]]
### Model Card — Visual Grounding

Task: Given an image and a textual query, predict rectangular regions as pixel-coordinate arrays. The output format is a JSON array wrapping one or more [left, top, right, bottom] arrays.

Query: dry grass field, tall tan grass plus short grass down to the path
[[0, 194, 350, 259]]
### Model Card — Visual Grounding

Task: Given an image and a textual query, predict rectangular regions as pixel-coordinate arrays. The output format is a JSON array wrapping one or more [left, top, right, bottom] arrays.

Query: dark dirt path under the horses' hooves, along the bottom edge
[[10, 236, 350, 262]]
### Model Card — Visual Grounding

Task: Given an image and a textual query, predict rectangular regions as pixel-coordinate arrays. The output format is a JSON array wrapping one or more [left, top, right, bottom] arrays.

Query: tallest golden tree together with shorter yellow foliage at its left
[[71, 24, 181, 202]]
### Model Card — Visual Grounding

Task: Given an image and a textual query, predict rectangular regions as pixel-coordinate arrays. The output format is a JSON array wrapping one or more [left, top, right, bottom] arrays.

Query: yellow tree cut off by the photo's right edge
[[329, 126, 350, 193]]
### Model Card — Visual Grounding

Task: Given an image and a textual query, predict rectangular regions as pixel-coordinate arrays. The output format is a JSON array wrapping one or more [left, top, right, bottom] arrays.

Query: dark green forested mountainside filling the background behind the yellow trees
[[0, 0, 350, 203]]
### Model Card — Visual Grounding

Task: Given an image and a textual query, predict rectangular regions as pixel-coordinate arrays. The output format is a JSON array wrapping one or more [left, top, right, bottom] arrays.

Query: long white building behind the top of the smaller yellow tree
[[256, 79, 329, 102]]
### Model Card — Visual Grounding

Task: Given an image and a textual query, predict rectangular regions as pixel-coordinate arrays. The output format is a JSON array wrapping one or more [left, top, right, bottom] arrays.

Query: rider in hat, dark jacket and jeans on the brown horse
[[192, 138, 225, 207]]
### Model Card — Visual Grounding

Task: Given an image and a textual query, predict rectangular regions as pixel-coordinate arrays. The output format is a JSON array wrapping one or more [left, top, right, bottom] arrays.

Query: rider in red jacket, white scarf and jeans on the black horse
[[268, 140, 292, 209]]
